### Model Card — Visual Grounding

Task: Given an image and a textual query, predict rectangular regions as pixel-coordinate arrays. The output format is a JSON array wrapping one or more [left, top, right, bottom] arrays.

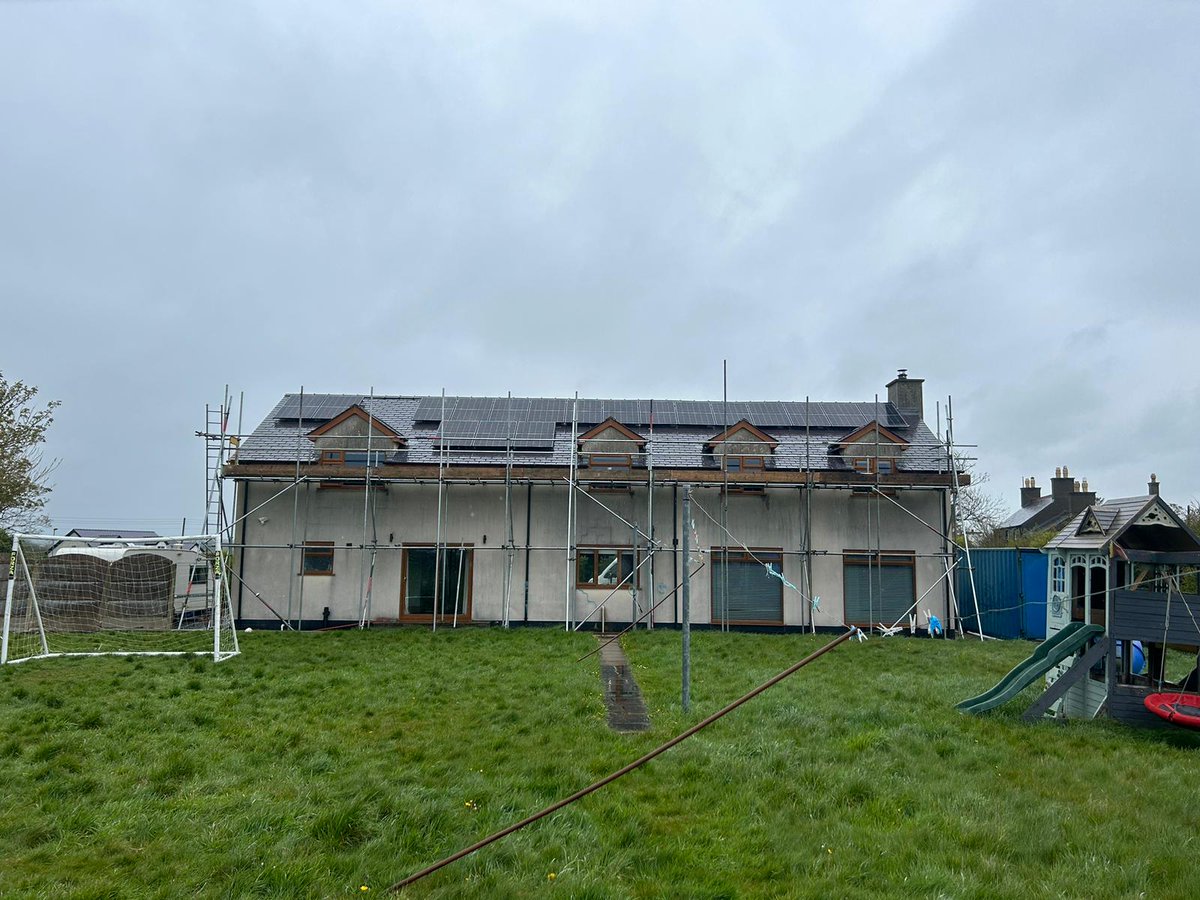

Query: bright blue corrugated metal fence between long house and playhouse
[[954, 547, 1048, 641]]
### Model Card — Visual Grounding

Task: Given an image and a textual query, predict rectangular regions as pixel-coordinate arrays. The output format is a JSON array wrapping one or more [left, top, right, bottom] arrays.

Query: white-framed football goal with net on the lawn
[[0, 534, 238, 664]]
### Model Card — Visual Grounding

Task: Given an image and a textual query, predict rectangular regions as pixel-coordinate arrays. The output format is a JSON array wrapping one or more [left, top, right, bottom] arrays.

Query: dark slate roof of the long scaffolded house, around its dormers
[[235, 394, 947, 473]]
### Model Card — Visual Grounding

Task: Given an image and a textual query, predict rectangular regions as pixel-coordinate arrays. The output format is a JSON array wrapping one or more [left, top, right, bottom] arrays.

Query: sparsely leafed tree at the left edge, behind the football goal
[[0, 372, 59, 545]]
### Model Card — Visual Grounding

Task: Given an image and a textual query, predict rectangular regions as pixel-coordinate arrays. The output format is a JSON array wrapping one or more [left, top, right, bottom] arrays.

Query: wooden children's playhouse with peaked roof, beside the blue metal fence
[[1034, 475, 1200, 725]]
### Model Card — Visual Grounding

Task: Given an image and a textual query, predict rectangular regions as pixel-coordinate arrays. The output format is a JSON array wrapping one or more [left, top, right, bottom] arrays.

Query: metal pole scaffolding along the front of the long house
[[218, 376, 978, 632]]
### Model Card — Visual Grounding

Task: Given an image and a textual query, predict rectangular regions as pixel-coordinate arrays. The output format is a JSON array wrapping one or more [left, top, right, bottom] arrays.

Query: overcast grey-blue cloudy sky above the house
[[0, 0, 1200, 533]]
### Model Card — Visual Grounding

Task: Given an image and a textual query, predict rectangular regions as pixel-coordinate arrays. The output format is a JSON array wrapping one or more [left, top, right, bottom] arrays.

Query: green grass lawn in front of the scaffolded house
[[0, 629, 1200, 898]]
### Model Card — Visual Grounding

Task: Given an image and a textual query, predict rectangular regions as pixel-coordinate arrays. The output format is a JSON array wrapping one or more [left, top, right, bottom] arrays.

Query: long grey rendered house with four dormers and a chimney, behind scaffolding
[[223, 371, 965, 629]]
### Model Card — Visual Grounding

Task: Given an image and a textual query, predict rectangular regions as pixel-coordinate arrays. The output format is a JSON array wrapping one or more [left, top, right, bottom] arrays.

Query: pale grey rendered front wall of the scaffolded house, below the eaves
[[235, 482, 949, 626]]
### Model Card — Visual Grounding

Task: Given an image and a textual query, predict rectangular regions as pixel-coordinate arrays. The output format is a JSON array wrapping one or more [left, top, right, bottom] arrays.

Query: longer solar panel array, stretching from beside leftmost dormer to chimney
[[412, 397, 908, 432]]
